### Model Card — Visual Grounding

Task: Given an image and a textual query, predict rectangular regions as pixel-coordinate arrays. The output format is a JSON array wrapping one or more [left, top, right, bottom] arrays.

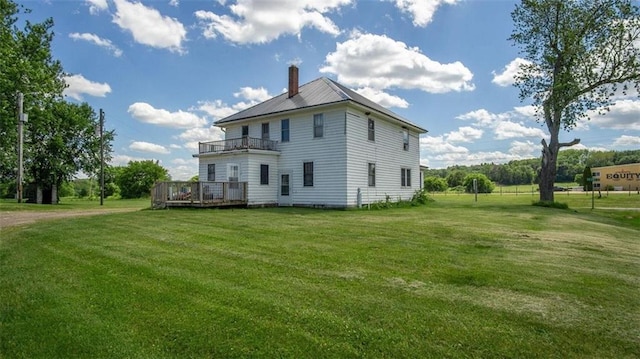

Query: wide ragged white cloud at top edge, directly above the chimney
[[195, 0, 352, 44]]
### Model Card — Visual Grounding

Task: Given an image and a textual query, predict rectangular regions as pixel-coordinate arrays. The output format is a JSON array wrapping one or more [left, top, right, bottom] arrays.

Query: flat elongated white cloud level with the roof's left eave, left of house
[[127, 102, 207, 128]]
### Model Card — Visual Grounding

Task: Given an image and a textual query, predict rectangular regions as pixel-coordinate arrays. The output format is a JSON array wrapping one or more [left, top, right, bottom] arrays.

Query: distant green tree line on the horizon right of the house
[[425, 149, 640, 190]]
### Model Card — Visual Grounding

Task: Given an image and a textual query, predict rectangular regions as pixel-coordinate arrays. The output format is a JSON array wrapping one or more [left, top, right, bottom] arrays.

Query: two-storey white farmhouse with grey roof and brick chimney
[[152, 66, 427, 208]]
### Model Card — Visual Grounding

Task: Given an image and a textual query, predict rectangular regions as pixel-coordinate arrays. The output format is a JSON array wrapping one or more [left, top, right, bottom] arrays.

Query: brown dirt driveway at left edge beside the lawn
[[0, 208, 140, 229]]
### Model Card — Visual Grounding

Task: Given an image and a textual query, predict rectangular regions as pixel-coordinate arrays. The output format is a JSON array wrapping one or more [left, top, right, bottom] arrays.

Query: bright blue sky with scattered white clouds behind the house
[[18, 0, 640, 180]]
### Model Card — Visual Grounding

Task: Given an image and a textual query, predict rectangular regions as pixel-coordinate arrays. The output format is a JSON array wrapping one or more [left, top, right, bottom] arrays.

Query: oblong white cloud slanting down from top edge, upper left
[[113, 0, 187, 54]]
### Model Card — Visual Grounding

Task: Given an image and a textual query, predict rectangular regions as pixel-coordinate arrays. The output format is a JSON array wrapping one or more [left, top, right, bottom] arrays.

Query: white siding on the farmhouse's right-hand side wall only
[[347, 109, 420, 206]]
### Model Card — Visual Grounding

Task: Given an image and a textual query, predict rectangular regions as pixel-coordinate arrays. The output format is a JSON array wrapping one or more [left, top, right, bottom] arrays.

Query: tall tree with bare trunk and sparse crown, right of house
[[510, 0, 640, 201]]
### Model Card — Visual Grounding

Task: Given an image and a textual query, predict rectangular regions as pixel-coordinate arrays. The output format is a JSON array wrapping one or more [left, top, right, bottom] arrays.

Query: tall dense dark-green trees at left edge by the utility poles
[[0, 0, 114, 200]]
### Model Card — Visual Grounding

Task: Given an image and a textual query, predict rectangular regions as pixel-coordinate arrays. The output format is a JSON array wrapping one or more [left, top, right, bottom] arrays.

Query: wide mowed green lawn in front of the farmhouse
[[0, 195, 640, 358]]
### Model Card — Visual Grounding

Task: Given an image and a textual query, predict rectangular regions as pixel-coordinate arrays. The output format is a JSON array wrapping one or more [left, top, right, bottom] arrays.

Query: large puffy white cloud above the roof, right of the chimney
[[320, 32, 475, 93]]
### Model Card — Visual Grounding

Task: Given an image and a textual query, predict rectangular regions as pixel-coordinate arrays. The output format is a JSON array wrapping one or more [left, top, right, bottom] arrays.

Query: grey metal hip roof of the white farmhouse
[[215, 77, 427, 133]]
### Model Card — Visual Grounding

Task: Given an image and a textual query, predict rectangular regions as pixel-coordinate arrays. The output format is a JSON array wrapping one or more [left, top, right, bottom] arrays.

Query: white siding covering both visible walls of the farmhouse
[[206, 103, 420, 207]]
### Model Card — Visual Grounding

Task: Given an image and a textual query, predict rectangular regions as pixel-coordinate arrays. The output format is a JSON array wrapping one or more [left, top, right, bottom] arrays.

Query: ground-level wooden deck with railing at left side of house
[[151, 181, 247, 209]]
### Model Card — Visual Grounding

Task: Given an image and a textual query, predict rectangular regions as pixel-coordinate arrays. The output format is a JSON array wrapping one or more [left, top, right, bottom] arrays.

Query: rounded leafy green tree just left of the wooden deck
[[116, 160, 170, 198]]
